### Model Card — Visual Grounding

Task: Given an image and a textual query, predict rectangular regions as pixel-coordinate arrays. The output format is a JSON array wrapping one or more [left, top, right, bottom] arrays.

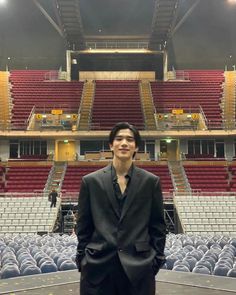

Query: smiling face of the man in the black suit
[[110, 129, 138, 161]]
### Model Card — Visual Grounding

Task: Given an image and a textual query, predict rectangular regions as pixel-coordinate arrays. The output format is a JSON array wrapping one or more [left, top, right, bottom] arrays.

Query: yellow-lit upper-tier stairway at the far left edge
[[0, 72, 10, 129]]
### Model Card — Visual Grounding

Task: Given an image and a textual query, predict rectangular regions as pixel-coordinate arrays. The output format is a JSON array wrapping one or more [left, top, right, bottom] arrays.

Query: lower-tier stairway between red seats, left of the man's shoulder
[[46, 162, 66, 192]]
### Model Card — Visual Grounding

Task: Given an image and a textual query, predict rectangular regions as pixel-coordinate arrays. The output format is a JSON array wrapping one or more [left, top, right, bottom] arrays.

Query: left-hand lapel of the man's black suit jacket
[[102, 164, 120, 218]]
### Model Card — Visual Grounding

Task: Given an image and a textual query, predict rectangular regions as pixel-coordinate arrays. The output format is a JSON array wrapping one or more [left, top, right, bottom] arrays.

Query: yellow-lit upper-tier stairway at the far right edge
[[223, 71, 236, 129]]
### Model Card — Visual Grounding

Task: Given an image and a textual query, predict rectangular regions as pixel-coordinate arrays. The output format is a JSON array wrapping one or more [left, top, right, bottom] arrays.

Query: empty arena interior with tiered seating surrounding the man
[[0, 0, 236, 295]]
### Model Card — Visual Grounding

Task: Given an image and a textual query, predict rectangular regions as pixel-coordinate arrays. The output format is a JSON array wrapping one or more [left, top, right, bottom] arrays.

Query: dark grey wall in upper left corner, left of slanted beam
[[0, 0, 65, 70]]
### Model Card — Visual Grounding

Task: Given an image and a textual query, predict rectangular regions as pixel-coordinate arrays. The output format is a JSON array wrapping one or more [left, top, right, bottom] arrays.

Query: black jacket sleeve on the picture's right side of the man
[[149, 178, 166, 274]]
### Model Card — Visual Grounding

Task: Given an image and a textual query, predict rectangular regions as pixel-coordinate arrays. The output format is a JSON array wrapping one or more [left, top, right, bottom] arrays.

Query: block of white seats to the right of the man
[[174, 195, 236, 237]]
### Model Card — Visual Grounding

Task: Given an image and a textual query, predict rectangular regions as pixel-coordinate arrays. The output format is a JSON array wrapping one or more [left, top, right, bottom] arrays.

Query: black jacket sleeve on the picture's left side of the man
[[76, 178, 94, 271]]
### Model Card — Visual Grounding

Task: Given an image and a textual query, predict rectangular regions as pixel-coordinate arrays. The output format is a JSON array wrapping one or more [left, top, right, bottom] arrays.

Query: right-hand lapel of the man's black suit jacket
[[120, 166, 141, 221]]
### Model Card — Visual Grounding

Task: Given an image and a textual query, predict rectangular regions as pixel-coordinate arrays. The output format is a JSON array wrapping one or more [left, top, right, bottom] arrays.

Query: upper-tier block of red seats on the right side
[[151, 71, 224, 129]]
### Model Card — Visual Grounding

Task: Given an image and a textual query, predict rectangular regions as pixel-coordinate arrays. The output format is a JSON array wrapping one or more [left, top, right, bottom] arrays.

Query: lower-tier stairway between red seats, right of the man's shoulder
[[168, 161, 191, 195]]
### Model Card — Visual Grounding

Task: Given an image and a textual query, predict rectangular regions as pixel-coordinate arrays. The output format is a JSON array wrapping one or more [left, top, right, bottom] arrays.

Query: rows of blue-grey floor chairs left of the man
[[0, 233, 77, 283]]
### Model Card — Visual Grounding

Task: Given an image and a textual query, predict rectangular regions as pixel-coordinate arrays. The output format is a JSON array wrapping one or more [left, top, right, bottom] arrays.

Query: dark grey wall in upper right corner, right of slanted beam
[[168, 0, 236, 70]]
